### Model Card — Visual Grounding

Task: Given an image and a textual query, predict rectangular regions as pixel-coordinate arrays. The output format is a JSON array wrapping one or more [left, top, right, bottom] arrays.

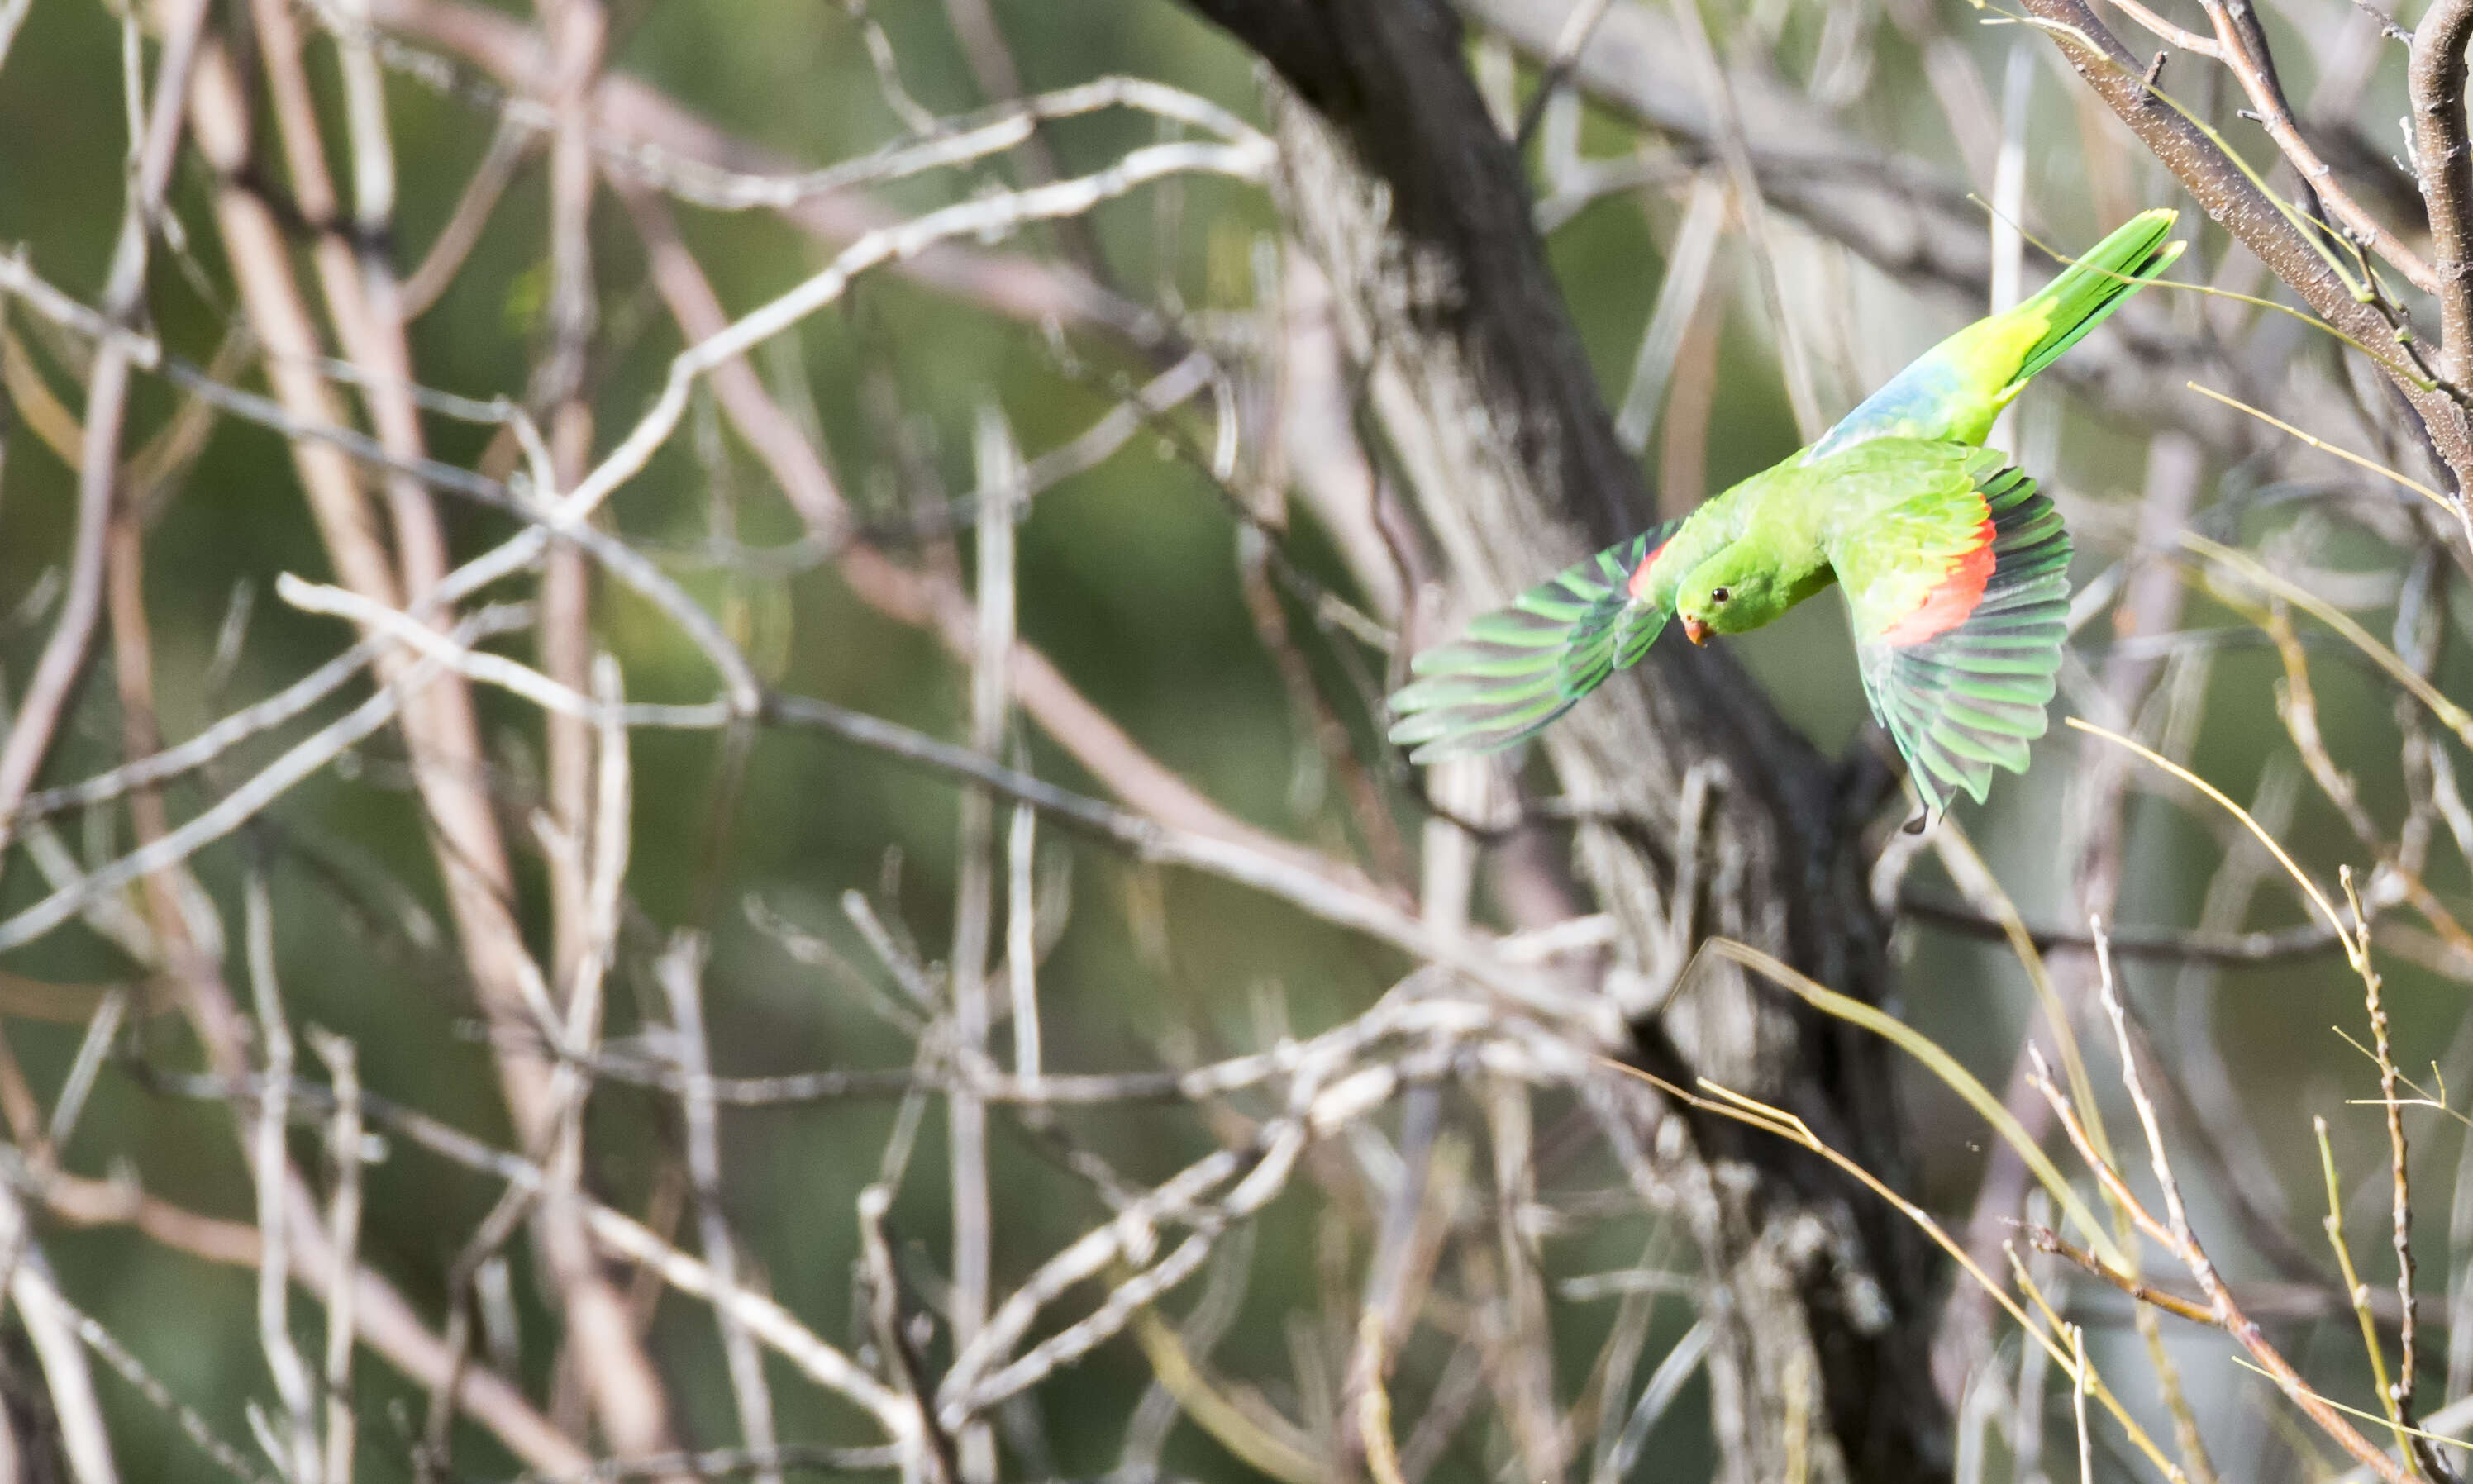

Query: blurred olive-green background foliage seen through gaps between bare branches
[[0, 0, 2473, 1479]]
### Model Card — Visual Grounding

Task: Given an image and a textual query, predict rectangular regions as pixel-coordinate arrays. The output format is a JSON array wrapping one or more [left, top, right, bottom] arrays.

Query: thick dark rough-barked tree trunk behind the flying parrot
[[1192, 0, 1949, 1484]]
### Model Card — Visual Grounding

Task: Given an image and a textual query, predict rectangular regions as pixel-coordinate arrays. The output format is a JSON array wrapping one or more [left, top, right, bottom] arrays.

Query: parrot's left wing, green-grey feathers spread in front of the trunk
[[1390, 520, 1684, 762]]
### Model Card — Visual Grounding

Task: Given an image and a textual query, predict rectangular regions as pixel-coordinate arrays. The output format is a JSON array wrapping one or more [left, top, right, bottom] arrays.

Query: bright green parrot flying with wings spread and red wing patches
[[1390, 210, 2184, 829]]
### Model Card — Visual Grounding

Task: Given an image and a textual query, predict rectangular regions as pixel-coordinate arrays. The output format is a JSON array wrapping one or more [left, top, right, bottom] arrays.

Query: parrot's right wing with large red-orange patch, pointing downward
[[1830, 448, 2070, 819]]
